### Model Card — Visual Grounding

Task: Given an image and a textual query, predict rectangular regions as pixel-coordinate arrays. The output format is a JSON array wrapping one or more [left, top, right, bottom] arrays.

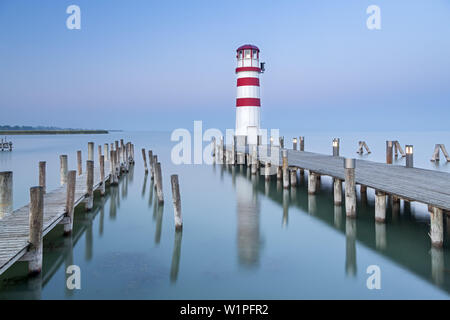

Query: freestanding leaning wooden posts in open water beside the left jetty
[[142, 148, 183, 230]]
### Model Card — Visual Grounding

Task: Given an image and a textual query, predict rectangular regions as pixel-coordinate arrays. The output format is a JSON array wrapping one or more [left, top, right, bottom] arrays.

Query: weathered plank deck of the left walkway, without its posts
[[0, 161, 110, 274]]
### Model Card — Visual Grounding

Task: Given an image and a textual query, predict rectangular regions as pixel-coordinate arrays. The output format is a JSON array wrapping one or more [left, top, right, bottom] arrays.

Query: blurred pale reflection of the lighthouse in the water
[[236, 175, 261, 267]]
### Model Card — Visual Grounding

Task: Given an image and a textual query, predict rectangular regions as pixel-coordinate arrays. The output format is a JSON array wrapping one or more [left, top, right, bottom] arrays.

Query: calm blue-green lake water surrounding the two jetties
[[0, 132, 450, 299]]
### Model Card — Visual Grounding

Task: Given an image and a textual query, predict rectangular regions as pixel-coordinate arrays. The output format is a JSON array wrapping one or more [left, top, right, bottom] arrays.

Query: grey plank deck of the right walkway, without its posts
[[234, 146, 450, 211]]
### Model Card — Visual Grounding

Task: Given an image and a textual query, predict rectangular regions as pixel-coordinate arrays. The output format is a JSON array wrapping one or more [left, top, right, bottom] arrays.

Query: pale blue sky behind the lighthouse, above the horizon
[[0, 0, 450, 133]]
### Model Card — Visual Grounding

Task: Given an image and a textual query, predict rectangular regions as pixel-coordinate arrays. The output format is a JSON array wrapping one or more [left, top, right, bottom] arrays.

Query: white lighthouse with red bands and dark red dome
[[235, 44, 264, 145]]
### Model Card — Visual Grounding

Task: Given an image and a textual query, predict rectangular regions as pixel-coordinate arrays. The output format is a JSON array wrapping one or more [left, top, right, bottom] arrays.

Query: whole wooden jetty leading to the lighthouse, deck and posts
[[217, 137, 450, 247]]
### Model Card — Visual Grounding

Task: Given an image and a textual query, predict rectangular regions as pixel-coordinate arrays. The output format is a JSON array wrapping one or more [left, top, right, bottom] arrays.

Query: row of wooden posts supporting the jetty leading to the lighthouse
[[212, 137, 444, 247]]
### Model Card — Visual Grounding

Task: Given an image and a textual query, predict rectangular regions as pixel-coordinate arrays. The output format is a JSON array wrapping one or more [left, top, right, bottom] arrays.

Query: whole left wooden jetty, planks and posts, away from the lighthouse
[[0, 140, 134, 274]]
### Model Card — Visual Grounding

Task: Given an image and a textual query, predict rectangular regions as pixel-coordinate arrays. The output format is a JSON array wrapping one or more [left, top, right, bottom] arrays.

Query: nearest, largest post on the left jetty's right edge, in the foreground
[[27, 187, 44, 274]]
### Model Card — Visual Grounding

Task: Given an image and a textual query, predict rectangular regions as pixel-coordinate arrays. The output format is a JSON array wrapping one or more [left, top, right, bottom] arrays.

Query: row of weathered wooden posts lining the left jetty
[[0, 139, 134, 274]]
